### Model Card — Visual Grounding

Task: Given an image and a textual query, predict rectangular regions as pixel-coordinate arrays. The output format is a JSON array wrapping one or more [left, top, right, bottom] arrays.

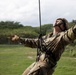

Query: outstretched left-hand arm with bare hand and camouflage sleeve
[[11, 35, 38, 48]]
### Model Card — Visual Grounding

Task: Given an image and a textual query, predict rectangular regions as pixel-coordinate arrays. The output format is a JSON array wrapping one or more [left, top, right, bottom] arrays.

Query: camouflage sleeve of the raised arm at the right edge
[[62, 25, 76, 45]]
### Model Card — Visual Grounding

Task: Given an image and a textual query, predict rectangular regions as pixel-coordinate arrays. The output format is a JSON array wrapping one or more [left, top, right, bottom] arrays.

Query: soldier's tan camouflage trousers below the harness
[[22, 61, 55, 75]]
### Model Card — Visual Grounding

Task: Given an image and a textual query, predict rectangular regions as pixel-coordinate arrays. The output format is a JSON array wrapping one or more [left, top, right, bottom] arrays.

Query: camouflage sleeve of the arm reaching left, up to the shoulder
[[19, 34, 50, 48]]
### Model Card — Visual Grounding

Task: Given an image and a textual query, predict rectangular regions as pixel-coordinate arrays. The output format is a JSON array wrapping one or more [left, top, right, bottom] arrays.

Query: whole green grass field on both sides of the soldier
[[0, 45, 76, 75]]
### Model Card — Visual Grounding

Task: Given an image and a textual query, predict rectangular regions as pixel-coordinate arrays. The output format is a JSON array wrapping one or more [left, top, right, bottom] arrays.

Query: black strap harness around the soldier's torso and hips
[[36, 35, 56, 67]]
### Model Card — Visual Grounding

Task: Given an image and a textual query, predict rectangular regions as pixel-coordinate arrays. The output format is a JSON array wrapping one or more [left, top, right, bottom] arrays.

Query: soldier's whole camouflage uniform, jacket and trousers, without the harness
[[20, 26, 76, 75]]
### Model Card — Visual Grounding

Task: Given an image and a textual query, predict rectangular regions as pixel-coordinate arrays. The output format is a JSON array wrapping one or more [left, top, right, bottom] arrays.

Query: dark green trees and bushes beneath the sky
[[0, 20, 76, 44]]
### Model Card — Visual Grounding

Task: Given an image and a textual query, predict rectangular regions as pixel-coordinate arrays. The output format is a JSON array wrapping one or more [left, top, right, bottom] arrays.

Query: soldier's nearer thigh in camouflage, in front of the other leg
[[27, 62, 48, 75]]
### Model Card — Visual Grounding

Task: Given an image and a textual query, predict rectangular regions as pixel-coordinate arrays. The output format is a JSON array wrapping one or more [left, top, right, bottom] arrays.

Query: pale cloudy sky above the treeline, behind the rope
[[0, 0, 76, 27]]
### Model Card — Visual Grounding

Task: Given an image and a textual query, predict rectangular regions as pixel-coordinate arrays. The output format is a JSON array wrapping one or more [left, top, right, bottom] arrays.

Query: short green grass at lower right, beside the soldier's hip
[[54, 57, 76, 75]]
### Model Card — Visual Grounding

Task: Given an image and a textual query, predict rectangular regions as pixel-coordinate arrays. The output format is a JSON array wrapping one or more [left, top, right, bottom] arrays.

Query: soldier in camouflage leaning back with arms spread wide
[[12, 18, 76, 75]]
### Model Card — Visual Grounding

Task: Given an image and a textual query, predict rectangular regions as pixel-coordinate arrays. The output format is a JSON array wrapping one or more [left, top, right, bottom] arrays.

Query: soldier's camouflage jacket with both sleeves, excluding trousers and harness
[[20, 26, 76, 61]]
